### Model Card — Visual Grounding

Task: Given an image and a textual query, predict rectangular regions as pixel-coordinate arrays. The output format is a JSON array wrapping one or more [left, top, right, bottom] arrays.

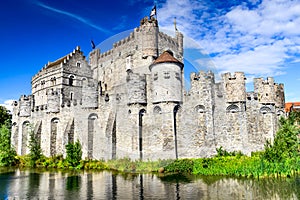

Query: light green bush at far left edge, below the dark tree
[[0, 122, 17, 166]]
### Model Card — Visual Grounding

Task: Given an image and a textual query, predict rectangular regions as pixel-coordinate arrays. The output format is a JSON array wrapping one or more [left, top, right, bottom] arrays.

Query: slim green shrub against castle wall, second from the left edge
[[29, 127, 42, 167]]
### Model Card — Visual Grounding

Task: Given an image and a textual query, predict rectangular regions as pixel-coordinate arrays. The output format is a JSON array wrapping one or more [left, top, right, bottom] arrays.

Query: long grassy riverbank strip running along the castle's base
[[17, 155, 300, 178]]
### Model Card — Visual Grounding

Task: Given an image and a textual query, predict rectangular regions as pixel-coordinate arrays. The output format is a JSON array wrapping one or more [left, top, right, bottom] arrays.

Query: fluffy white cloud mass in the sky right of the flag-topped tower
[[158, 0, 300, 76]]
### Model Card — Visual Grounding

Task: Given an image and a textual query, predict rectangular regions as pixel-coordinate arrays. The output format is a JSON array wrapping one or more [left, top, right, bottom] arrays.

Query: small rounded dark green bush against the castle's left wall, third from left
[[66, 141, 82, 168]]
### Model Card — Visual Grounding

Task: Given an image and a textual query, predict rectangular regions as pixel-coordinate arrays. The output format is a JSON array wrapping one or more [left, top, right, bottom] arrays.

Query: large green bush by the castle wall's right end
[[263, 114, 300, 162]]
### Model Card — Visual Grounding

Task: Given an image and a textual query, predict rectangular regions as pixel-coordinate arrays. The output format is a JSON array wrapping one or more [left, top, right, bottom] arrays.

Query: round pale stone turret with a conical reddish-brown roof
[[150, 51, 183, 103]]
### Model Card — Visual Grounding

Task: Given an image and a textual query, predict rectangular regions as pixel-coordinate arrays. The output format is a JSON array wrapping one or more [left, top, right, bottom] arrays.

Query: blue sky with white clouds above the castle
[[0, 0, 300, 111]]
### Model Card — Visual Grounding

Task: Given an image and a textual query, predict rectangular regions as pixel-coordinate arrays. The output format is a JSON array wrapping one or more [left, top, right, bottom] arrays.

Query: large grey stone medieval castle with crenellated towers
[[11, 17, 284, 160]]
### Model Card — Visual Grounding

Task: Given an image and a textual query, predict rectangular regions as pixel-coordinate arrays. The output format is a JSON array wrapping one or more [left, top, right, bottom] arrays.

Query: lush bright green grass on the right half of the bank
[[165, 156, 300, 178]]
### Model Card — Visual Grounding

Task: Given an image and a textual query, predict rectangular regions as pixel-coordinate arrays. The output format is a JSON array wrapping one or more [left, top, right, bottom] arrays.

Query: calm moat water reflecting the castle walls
[[0, 168, 300, 200]]
